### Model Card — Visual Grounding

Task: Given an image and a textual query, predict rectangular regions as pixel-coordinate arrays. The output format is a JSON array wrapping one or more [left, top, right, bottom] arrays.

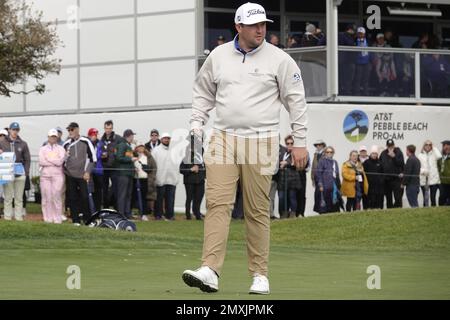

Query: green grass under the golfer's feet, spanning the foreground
[[0, 208, 450, 300]]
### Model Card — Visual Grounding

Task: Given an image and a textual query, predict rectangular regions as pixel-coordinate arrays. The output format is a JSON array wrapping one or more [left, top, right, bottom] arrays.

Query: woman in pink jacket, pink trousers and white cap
[[39, 129, 66, 223]]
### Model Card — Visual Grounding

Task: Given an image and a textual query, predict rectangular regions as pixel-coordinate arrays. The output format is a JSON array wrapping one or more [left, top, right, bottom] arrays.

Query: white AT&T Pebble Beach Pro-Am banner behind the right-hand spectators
[[281, 104, 450, 215]]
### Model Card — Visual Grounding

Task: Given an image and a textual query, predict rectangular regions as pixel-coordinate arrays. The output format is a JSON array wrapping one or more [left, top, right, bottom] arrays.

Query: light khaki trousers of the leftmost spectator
[[3, 176, 26, 221]]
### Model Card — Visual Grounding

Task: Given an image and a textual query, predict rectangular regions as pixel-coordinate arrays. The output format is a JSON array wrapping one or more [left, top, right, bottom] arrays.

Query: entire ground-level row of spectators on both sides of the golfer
[[0, 121, 450, 225]]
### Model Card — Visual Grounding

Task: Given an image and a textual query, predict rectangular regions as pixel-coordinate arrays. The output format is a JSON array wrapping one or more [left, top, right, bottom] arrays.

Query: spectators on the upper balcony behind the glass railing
[[214, 23, 450, 98]]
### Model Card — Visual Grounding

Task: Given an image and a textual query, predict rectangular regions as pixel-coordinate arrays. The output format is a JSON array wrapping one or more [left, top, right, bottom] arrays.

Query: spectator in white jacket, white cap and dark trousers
[[152, 132, 181, 220]]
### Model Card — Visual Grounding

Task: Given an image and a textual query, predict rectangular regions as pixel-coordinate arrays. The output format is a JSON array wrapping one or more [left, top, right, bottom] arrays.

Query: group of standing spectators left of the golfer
[[0, 121, 205, 225]]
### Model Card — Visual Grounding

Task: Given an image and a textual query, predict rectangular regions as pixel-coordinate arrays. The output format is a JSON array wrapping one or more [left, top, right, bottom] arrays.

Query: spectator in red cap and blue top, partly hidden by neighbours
[[88, 128, 103, 210]]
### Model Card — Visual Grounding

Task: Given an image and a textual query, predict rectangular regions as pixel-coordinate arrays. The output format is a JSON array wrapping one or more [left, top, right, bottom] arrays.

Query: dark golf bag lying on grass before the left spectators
[[86, 209, 136, 232]]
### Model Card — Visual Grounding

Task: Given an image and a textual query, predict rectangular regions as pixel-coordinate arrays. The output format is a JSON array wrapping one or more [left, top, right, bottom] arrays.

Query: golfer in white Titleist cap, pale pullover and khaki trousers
[[183, 3, 307, 294]]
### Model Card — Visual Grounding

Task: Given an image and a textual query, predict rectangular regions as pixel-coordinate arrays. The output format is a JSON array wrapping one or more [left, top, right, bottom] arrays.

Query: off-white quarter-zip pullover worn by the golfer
[[191, 38, 307, 147]]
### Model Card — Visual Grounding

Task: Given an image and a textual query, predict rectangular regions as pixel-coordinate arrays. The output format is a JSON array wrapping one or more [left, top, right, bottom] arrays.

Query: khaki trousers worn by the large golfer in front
[[202, 132, 279, 275]]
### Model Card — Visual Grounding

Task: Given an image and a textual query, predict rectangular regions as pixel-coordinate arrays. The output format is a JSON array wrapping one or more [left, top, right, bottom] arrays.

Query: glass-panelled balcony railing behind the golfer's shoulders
[[199, 46, 450, 105]]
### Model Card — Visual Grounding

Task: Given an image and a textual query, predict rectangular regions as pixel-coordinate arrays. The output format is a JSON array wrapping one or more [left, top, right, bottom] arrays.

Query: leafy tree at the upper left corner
[[0, 0, 61, 97]]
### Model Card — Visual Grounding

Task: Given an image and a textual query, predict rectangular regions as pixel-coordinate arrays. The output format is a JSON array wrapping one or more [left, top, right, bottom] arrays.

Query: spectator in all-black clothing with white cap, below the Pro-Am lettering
[[363, 146, 384, 209]]
